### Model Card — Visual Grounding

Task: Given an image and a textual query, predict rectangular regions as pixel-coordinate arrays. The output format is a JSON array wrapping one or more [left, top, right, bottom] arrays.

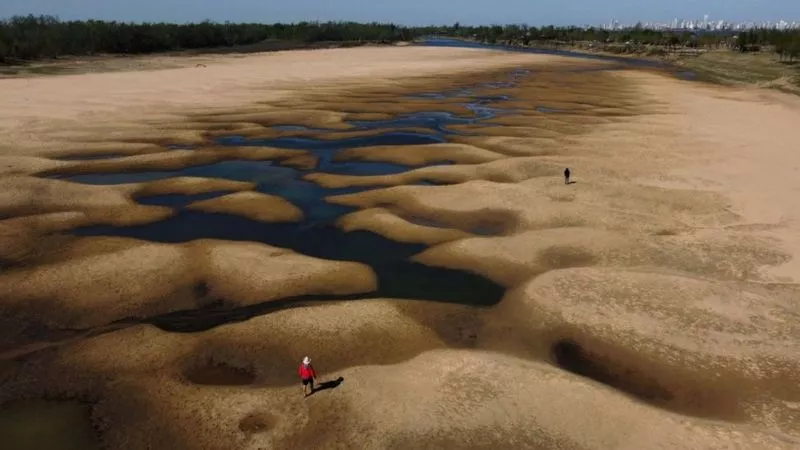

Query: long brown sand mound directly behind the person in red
[[4, 300, 444, 393]]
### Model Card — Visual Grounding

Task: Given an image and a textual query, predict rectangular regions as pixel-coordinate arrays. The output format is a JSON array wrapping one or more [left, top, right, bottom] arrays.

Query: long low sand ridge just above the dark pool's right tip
[[416, 224, 787, 287]]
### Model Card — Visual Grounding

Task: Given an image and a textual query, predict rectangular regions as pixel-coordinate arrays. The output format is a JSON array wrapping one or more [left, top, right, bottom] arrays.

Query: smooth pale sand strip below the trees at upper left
[[0, 46, 569, 156]]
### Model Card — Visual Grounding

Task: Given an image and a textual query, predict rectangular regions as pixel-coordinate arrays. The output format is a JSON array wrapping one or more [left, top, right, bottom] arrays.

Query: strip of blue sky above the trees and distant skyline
[[0, 0, 800, 25]]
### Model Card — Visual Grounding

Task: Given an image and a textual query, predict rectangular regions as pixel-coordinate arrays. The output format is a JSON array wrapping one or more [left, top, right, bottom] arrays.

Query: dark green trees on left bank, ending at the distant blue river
[[0, 15, 414, 62]]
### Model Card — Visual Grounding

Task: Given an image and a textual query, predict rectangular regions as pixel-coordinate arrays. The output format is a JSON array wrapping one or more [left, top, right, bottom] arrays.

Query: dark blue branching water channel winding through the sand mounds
[[54, 71, 580, 322]]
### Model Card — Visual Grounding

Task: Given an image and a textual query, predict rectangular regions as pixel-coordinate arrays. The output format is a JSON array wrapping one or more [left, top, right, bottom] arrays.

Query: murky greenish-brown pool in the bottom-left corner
[[0, 400, 99, 450]]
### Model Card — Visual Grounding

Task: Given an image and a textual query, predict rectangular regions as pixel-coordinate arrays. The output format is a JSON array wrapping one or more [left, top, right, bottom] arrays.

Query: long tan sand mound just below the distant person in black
[[327, 177, 737, 239]]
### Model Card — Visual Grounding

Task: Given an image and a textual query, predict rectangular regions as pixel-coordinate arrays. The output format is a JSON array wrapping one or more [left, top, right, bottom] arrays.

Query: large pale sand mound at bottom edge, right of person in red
[[281, 350, 797, 450]]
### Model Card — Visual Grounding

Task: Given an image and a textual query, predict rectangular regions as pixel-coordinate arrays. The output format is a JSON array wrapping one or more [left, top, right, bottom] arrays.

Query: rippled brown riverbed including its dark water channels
[[0, 48, 800, 450]]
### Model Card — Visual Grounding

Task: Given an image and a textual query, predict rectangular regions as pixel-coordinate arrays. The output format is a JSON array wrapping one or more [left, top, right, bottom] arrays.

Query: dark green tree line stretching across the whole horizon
[[0, 15, 800, 63]]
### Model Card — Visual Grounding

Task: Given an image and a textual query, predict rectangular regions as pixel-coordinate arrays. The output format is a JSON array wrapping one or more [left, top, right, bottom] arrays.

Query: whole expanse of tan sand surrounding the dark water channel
[[0, 44, 800, 450]]
